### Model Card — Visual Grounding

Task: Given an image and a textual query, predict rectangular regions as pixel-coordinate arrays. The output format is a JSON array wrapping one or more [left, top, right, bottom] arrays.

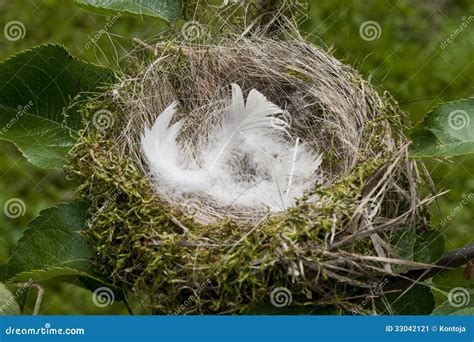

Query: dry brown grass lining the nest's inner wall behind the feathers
[[115, 26, 412, 222]]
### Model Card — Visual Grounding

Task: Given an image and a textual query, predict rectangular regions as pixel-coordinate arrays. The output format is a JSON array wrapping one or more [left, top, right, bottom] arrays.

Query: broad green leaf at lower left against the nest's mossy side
[[2, 203, 95, 282]]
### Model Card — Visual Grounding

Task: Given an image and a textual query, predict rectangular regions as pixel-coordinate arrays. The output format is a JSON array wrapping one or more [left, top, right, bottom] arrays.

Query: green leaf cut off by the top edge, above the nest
[[75, 0, 182, 22]]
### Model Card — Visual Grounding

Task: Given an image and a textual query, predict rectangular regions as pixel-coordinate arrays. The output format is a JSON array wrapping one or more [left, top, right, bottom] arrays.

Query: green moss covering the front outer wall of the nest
[[68, 111, 402, 313]]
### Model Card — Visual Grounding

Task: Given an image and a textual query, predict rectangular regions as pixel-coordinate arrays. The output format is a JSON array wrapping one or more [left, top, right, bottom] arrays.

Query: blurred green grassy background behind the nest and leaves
[[0, 0, 474, 314]]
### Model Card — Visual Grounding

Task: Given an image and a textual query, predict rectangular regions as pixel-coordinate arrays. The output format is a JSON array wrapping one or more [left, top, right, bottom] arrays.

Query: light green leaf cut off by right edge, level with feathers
[[410, 98, 474, 158]]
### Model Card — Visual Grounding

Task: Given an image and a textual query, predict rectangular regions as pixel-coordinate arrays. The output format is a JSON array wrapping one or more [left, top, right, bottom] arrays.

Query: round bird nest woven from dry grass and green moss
[[69, 30, 434, 314]]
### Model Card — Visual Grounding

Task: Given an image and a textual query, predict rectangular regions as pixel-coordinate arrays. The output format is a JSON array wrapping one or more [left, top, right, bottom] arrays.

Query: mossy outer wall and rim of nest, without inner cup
[[66, 30, 434, 313]]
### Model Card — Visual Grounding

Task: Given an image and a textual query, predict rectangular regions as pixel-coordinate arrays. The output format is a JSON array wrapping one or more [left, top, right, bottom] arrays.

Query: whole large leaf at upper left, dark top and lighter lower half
[[0, 44, 113, 168]]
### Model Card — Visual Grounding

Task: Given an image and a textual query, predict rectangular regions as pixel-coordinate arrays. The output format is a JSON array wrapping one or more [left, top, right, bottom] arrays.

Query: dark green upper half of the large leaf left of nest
[[0, 44, 114, 129]]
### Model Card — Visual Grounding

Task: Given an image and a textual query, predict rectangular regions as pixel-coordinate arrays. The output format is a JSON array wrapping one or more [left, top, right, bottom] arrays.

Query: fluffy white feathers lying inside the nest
[[141, 84, 321, 211]]
